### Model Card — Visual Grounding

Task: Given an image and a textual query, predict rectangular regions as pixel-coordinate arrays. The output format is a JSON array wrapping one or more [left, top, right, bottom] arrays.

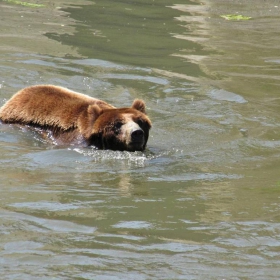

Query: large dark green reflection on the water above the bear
[[46, 0, 208, 77]]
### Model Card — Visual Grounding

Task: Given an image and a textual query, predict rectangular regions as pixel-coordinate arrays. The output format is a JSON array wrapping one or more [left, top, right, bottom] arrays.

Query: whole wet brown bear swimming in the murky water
[[0, 85, 151, 151]]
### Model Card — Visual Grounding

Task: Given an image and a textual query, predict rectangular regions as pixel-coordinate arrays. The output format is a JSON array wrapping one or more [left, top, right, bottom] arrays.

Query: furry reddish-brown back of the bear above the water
[[0, 85, 115, 130]]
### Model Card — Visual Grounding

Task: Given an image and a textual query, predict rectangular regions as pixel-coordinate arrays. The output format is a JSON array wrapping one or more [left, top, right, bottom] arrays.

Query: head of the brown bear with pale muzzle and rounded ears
[[78, 99, 151, 151]]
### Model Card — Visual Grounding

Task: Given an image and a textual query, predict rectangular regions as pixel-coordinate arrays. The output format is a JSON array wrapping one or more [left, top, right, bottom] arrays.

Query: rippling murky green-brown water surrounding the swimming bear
[[0, 0, 280, 280]]
